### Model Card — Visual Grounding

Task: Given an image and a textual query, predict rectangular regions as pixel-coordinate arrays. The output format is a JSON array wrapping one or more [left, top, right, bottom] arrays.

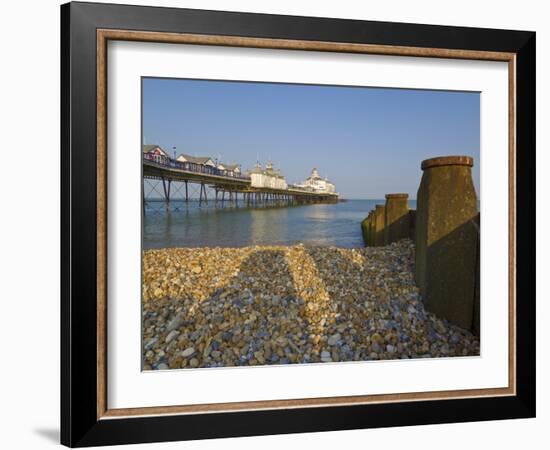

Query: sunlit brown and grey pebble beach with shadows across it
[[142, 240, 479, 370]]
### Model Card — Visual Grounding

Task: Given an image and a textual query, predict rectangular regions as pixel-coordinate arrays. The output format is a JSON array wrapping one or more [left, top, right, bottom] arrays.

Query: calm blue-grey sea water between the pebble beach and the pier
[[143, 200, 416, 249]]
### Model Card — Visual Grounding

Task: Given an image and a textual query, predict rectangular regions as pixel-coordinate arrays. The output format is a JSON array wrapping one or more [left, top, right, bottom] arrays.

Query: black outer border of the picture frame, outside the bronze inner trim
[[61, 2, 536, 447]]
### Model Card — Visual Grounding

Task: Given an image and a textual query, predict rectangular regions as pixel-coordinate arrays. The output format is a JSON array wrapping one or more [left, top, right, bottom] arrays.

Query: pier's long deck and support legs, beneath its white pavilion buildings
[[142, 154, 338, 211]]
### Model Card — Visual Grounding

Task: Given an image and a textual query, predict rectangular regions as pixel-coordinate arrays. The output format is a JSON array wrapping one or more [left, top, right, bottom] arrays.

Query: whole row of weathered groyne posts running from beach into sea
[[361, 156, 480, 334]]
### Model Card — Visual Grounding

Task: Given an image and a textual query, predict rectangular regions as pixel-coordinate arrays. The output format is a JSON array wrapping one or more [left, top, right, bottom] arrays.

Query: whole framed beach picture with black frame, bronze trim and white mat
[[61, 3, 535, 447]]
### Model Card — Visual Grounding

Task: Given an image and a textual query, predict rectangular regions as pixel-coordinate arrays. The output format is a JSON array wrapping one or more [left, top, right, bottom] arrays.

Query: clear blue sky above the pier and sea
[[143, 78, 480, 199]]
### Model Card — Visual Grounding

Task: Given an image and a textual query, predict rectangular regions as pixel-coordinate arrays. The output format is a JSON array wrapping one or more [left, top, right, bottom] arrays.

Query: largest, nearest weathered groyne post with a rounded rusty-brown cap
[[415, 156, 478, 329]]
